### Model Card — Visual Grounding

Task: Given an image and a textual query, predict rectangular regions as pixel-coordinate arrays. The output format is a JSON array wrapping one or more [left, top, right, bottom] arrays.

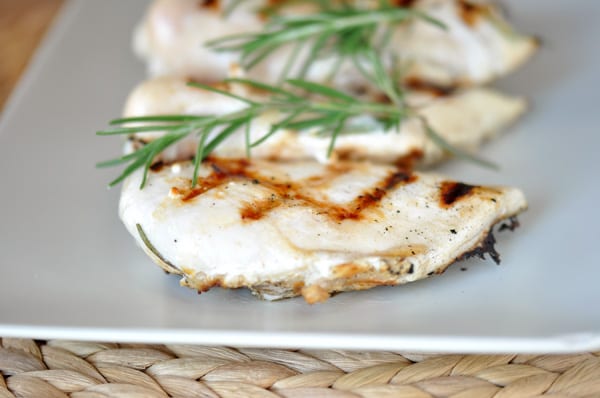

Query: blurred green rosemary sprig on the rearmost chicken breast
[[206, 1, 445, 81]]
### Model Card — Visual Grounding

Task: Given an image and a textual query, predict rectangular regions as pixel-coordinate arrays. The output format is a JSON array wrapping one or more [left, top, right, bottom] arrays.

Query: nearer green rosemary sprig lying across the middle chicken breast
[[97, 79, 409, 188]]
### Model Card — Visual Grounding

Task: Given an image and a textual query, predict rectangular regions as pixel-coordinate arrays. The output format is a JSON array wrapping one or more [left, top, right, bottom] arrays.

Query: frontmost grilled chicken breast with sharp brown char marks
[[120, 158, 527, 303]]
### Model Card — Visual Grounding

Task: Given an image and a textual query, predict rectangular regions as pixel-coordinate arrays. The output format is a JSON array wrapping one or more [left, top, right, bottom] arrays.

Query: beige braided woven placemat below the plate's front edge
[[0, 338, 600, 398]]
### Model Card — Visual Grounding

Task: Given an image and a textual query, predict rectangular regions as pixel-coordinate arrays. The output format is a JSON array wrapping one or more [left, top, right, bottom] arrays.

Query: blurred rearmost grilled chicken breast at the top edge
[[134, 0, 537, 88]]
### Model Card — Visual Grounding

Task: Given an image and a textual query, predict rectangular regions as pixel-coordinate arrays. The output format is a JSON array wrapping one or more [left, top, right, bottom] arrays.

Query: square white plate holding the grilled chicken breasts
[[0, 0, 600, 353]]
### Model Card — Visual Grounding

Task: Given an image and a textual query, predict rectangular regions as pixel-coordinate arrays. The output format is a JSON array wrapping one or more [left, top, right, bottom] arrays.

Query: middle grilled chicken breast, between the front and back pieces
[[124, 77, 526, 165]]
